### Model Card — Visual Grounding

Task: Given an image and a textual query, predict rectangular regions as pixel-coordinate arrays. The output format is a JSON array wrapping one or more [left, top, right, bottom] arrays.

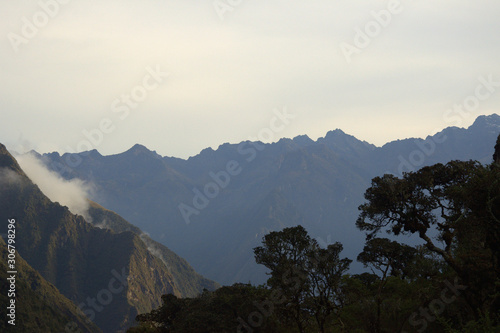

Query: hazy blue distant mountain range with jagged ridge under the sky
[[40, 114, 500, 284]]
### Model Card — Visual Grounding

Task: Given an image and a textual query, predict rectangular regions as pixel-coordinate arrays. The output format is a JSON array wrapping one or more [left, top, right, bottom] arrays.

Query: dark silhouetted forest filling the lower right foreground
[[128, 136, 500, 333]]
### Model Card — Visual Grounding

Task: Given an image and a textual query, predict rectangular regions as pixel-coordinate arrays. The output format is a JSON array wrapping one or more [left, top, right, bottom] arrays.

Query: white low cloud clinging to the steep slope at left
[[16, 154, 92, 221]]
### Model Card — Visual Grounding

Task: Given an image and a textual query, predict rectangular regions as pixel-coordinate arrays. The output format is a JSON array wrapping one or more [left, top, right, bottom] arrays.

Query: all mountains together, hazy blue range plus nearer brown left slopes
[[0, 114, 500, 332]]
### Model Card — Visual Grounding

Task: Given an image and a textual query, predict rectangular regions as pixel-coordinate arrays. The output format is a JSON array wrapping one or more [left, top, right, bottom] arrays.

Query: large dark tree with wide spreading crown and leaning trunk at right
[[356, 161, 482, 272]]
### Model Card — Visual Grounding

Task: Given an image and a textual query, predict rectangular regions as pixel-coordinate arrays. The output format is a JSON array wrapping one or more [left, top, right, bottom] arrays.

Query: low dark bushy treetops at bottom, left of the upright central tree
[[133, 284, 286, 333]]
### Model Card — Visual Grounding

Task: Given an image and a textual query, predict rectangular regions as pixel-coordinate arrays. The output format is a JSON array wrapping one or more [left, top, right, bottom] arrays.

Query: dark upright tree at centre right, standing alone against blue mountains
[[254, 226, 351, 332]]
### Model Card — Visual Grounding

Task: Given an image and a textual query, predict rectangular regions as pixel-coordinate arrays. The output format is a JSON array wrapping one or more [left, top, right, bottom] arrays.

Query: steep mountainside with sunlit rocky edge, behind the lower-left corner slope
[[0, 145, 191, 332]]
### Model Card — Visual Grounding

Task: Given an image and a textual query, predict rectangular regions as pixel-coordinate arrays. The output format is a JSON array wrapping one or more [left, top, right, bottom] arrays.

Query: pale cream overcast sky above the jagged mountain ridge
[[0, 0, 500, 158]]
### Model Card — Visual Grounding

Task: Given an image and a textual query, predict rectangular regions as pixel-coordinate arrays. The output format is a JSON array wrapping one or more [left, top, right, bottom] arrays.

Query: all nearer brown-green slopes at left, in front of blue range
[[0, 144, 218, 332]]
